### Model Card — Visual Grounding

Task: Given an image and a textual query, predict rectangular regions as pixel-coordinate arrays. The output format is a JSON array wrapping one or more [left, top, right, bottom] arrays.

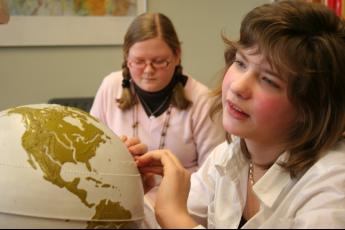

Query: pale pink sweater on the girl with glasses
[[90, 71, 225, 171]]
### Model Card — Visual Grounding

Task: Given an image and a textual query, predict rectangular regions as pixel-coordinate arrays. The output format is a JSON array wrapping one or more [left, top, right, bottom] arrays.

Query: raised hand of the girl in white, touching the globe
[[135, 150, 197, 228]]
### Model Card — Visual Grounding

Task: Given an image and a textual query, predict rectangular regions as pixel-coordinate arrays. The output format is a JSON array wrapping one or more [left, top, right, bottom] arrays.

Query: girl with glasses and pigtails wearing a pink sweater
[[90, 13, 225, 207]]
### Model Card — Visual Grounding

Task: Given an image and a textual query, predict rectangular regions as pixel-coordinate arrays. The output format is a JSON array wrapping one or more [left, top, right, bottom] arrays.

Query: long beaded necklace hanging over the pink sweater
[[132, 103, 172, 149]]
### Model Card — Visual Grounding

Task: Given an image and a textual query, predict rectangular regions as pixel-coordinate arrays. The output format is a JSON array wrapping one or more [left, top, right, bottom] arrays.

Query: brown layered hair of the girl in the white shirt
[[208, 1, 345, 177]]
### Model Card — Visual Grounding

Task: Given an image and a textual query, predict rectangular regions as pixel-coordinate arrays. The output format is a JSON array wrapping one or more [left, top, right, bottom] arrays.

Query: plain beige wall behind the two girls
[[0, 0, 269, 110]]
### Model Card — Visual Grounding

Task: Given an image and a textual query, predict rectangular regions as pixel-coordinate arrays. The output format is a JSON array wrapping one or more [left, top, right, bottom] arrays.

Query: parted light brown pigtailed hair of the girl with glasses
[[116, 13, 192, 110]]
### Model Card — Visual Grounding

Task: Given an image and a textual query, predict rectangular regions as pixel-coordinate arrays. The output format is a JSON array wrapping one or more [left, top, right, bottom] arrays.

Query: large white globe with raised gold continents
[[0, 104, 144, 228]]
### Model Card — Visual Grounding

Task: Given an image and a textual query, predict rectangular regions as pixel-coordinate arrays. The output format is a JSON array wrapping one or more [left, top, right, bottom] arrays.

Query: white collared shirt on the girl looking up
[[188, 138, 345, 228]]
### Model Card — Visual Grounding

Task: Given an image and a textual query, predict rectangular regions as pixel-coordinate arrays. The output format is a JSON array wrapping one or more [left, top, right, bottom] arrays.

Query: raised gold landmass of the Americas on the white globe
[[8, 106, 131, 223]]
